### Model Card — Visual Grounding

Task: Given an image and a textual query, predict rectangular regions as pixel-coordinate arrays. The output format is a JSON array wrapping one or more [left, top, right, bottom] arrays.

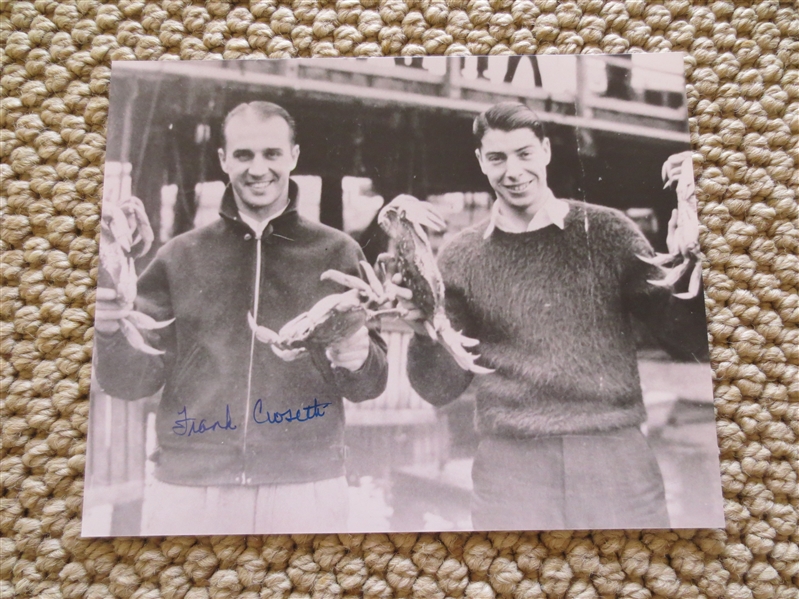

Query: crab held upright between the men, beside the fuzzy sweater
[[377, 195, 493, 374]]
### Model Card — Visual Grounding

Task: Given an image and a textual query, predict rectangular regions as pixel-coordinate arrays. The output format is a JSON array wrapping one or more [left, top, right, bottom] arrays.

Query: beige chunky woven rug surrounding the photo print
[[0, 0, 799, 599]]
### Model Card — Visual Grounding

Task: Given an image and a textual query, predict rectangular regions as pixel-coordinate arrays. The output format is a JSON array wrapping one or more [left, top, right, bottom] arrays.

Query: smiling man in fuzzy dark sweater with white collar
[[408, 104, 706, 530]]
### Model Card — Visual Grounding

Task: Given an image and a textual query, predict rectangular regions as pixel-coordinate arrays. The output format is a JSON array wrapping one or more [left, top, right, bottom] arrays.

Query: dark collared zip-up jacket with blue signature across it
[[96, 183, 387, 485]]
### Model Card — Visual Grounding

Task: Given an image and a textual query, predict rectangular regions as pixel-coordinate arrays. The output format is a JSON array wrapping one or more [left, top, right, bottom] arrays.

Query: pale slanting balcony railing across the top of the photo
[[114, 54, 688, 142]]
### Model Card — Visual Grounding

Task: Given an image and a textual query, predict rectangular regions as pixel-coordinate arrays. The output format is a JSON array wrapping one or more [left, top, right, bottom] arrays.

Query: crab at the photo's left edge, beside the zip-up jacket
[[98, 171, 174, 355]]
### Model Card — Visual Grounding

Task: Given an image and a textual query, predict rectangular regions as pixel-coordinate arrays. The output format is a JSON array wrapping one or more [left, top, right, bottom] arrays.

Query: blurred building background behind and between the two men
[[87, 54, 721, 534]]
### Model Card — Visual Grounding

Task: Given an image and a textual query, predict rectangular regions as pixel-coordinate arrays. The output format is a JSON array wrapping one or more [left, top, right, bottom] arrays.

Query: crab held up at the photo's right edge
[[639, 152, 702, 299]]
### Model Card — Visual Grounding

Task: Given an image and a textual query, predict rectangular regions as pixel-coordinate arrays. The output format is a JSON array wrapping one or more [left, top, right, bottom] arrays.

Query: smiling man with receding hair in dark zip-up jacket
[[96, 102, 387, 535]]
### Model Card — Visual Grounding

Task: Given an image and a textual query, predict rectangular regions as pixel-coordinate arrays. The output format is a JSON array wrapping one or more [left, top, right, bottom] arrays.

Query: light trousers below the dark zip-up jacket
[[141, 476, 349, 536]]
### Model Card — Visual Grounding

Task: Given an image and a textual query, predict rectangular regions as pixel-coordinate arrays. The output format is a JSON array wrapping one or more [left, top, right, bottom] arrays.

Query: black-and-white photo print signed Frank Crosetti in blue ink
[[83, 54, 724, 537]]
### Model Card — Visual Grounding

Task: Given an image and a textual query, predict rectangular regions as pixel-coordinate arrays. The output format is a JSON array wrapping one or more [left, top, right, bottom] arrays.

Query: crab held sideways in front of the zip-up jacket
[[247, 261, 401, 360]]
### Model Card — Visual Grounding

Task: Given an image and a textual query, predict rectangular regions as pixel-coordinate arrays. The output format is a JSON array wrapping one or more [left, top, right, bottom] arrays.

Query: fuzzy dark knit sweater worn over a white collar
[[408, 201, 707, 437]]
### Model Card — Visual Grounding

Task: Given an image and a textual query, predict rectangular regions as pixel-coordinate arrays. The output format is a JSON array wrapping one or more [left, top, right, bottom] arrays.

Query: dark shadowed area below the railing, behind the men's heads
[[107, 70, 686, 262]]
